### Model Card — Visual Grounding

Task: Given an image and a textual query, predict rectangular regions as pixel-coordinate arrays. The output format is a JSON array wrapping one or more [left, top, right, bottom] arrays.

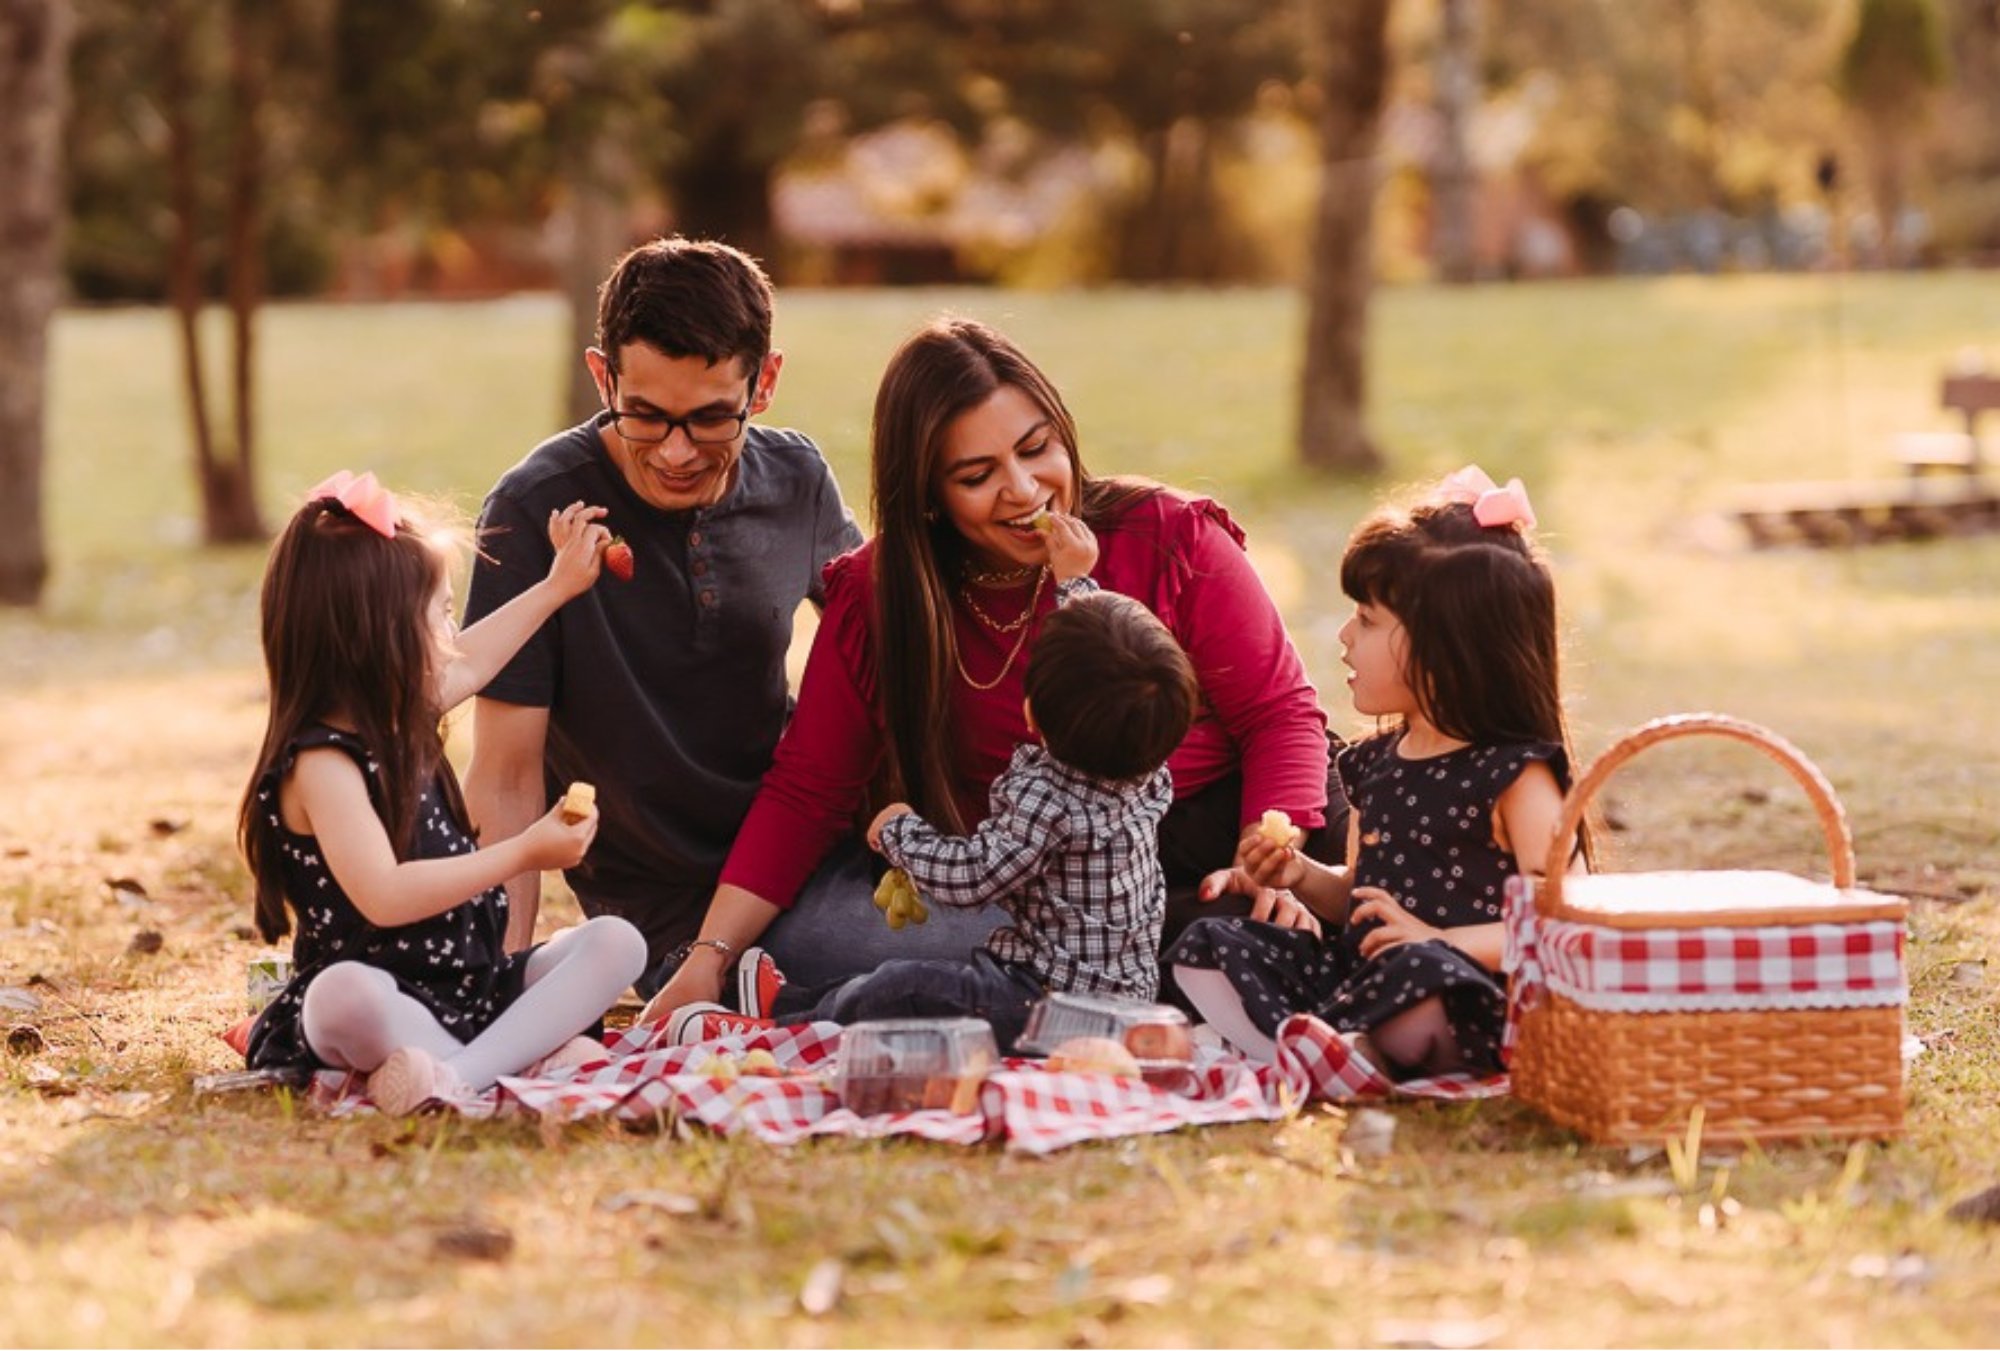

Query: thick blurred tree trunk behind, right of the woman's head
[[1298, 0, 1390, 472]]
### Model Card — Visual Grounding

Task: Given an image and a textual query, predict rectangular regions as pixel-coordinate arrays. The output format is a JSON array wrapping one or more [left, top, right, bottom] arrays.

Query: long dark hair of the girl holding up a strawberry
[[236, 498, 470, 941]]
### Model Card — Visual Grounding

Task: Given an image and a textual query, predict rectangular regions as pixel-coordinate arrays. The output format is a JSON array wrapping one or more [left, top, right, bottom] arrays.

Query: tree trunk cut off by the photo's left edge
[[0, 0, 72, 606]]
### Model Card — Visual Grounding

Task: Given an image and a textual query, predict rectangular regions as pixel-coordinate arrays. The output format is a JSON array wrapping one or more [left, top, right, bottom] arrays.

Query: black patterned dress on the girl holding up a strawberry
[[246, 727, 526, 1069]]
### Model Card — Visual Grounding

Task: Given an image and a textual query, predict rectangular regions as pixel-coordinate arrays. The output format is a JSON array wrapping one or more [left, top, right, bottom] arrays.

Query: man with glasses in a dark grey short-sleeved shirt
[[466, 238, 862, 993]]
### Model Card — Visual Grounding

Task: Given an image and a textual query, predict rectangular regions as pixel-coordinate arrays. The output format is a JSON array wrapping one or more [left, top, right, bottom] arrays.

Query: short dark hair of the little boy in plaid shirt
[[1026, 592, 1200, 779]]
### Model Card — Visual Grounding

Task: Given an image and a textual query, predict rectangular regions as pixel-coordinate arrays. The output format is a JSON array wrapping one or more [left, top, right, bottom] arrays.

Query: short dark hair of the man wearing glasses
[[598, 234, 772, 378]]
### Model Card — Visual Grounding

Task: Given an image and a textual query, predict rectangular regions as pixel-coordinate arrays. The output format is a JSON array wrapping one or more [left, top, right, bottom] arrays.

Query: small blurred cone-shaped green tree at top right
[[1840, 0, 1948, 260]]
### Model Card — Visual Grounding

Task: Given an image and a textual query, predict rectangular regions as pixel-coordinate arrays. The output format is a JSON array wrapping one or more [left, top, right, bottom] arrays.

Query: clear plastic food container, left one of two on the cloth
[[834, 1017, 1000, 1117]]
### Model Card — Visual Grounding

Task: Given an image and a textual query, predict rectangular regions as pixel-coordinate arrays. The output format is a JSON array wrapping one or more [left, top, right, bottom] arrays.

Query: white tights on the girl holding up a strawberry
[[300, 915, 646, 1091]]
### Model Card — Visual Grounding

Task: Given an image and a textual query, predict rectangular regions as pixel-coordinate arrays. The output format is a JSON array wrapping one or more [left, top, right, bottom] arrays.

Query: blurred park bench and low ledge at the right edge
[[1730, 363, 2000, 548]]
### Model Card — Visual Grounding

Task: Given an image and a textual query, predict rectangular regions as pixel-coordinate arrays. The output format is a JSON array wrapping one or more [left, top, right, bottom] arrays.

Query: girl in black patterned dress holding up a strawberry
[[238, 472, 646, 1115]]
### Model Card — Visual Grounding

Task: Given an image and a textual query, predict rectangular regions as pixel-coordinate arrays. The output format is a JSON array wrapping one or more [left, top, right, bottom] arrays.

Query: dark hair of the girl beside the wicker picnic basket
[[1340, 502, 1590, 859]]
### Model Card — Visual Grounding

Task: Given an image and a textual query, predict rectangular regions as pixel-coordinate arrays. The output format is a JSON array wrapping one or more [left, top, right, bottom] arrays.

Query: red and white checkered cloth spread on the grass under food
[[300, 1015, 1506, 1153]]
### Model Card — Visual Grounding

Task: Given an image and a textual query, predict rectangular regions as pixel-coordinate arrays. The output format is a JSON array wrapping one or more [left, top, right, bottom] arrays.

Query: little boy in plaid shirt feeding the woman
[[668, 578, 1198, 1047]]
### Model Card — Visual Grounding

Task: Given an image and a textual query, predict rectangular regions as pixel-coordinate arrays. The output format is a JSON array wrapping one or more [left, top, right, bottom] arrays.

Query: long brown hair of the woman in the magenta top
[[870, 318, 1160, 833]]
